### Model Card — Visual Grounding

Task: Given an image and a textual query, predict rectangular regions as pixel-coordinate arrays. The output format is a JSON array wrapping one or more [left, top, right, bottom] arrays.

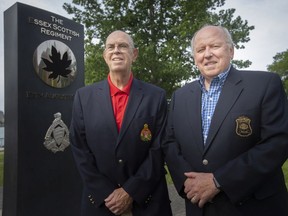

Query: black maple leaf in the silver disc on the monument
[[42, 46, 71, 82]]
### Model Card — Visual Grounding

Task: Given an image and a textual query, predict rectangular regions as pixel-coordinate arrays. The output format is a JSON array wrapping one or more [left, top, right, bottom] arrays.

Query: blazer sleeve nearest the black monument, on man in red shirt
[[70, 91, 115, 206]]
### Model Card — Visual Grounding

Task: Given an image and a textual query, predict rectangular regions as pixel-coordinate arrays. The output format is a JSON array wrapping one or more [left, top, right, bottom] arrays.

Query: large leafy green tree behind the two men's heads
[[63, 0, 254, 97]]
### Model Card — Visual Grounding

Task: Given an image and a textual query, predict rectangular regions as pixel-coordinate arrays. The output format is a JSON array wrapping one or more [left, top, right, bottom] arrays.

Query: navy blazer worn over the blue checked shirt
[[163, 67, 288, 216]]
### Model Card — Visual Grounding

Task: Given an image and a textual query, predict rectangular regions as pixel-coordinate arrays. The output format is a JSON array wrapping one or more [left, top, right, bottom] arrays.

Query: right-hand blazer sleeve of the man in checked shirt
[[214, 73, 288, 203]]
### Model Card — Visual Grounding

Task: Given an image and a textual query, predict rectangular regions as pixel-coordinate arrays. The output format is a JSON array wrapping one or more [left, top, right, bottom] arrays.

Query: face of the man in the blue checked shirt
[[194, 26, 234, 80]]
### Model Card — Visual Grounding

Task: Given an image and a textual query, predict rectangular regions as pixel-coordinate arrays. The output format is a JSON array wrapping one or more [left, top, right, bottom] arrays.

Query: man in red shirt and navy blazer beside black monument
[[70, 31, 172, 216]]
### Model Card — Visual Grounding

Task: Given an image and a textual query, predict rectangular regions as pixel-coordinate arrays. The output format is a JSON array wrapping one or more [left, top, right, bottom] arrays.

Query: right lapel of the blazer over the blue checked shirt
[[205, 68, 243, 150]]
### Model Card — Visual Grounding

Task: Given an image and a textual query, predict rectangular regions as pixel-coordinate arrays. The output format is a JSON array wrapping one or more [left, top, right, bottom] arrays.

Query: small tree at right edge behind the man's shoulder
[[267, 49, 288, 94]]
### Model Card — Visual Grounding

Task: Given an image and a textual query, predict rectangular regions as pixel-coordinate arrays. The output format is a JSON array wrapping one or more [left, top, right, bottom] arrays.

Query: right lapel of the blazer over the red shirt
[[117, 79, 143, 145]]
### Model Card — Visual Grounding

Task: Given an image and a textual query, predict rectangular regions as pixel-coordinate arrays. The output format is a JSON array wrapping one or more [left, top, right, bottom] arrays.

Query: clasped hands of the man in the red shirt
[[104, 188, 133, 215]]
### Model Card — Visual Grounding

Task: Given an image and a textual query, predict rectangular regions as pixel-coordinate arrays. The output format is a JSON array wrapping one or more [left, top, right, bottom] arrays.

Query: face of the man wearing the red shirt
[[103, 32, 138, 73]]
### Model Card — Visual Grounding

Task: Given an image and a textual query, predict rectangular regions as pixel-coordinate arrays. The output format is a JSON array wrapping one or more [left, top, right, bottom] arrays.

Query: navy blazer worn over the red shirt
[[70, 79, 172, 216]]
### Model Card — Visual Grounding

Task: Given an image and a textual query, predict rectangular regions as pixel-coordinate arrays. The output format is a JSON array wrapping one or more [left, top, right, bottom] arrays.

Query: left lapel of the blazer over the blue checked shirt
[[186, 82, 204, 152]]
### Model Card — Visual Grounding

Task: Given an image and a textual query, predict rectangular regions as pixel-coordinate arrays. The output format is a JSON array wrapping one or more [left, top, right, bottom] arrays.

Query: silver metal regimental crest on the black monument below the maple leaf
[[44, 112, 70, 153]]
